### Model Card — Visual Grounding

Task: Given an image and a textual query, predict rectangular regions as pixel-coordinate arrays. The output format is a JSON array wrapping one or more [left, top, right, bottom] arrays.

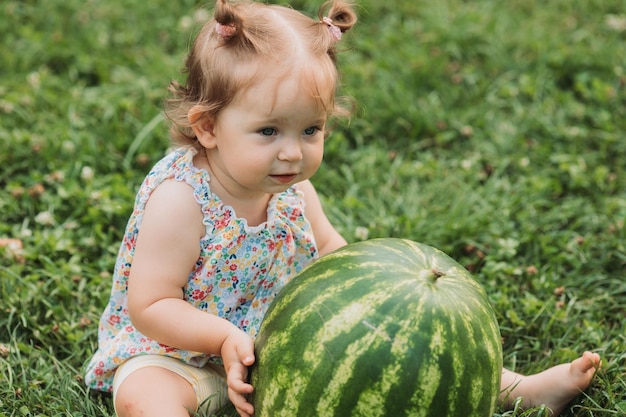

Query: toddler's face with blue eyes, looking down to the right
[[207, 76, 327, 197]]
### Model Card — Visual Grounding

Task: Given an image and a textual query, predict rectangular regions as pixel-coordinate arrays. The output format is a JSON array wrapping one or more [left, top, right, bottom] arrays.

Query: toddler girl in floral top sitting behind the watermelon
[[86, 0, 598, 417]]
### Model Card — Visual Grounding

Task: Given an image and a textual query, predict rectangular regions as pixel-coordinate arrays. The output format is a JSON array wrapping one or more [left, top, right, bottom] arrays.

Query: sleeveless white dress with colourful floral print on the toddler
[[85, 148, 318, 391]]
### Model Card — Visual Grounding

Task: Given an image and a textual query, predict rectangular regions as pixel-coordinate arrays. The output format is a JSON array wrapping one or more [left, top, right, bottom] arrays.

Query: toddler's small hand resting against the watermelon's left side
[[221, 329, 254, 417]]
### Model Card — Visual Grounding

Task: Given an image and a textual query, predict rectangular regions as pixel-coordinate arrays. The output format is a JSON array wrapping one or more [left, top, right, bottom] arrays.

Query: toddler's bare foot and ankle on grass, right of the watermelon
[[501, 352, 600, 416]]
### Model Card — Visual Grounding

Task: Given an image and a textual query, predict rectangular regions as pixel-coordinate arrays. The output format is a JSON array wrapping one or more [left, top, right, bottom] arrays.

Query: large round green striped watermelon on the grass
[[251, 239, 502, 417]]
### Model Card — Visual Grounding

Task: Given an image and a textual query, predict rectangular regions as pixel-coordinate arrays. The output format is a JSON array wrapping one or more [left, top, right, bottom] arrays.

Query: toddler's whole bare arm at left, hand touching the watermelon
[[128, 180, 254, 416]]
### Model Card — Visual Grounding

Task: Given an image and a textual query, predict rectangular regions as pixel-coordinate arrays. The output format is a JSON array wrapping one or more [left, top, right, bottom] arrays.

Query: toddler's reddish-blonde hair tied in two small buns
[[165, 0, 356, 147]]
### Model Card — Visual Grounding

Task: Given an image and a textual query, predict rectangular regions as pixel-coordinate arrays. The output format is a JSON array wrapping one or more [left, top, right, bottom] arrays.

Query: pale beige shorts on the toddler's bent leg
[[113, 355, 228, 413]]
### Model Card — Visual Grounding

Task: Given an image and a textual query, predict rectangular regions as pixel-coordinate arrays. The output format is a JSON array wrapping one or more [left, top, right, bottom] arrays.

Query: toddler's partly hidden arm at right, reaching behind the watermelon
[[298, 180, 347, 256]]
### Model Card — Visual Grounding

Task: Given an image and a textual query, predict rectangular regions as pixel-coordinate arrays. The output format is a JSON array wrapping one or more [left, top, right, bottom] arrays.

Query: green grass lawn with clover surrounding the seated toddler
[[0, 0, 626, 417]]
